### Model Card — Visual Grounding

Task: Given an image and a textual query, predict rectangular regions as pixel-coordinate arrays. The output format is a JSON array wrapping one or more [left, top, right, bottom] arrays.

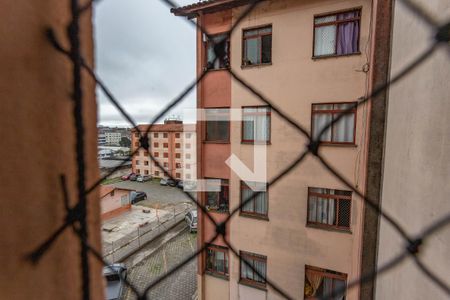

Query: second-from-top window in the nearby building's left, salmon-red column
[[206, 108, 230, 142]]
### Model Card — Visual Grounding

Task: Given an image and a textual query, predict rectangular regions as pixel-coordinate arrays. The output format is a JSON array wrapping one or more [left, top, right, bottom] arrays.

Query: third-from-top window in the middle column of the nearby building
[[241, 181, 268, 216]]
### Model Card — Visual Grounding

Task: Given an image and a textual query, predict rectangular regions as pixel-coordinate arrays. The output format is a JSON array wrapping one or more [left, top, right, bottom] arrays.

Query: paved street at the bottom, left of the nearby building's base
[[123, 223, 197, 300]]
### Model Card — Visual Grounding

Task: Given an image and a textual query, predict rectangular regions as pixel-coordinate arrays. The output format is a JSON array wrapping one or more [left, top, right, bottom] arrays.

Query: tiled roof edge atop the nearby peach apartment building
[[170, 0, 255, 18]]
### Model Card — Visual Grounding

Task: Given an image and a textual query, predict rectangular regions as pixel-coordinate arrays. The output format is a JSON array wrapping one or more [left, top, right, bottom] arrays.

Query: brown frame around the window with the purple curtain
[[312, 7, 362, 58]]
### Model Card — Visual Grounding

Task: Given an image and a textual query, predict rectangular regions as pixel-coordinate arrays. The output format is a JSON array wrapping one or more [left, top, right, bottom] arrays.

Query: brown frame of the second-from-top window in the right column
[[311, 102, 358, 145]]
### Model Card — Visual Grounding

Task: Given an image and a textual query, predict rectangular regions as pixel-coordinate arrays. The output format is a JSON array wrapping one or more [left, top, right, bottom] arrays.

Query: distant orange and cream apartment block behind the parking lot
[[131, 119, 196, 180]]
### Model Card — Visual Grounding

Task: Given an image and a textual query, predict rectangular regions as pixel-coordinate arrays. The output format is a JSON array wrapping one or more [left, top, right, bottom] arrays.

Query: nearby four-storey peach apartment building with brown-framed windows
[[172, 0, 389, 300]]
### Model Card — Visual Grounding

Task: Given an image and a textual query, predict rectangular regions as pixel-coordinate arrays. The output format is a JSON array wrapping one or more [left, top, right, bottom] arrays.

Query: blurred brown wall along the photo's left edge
[[0, 0, 103, 300]]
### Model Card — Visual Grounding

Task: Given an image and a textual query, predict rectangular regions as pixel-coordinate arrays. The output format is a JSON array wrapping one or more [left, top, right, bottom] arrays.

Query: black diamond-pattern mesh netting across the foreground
[[29, 0, 450, 299]]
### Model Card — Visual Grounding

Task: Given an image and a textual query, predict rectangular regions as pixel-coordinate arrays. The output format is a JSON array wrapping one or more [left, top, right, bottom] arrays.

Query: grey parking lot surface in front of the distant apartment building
[[112, 179, 192, 208]]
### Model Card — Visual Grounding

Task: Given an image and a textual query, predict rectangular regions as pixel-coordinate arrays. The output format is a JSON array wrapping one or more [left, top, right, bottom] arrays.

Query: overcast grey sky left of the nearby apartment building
[[94, 0, 195, 126]]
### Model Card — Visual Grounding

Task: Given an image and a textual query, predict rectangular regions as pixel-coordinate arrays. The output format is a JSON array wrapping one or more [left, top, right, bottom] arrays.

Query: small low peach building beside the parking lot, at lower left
[[100, 185, 134, 220]]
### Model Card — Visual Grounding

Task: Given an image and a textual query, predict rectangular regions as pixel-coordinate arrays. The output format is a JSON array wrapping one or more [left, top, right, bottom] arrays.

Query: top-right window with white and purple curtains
[[314, 9, 361, 57]]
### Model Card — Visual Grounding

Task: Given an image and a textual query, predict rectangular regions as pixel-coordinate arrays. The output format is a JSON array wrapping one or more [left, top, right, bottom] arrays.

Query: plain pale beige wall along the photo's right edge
[[376, 0, 450, 299]]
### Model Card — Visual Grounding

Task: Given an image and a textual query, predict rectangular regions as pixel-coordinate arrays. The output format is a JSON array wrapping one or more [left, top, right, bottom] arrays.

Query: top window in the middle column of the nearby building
[[242, 26, 272, 66]]
